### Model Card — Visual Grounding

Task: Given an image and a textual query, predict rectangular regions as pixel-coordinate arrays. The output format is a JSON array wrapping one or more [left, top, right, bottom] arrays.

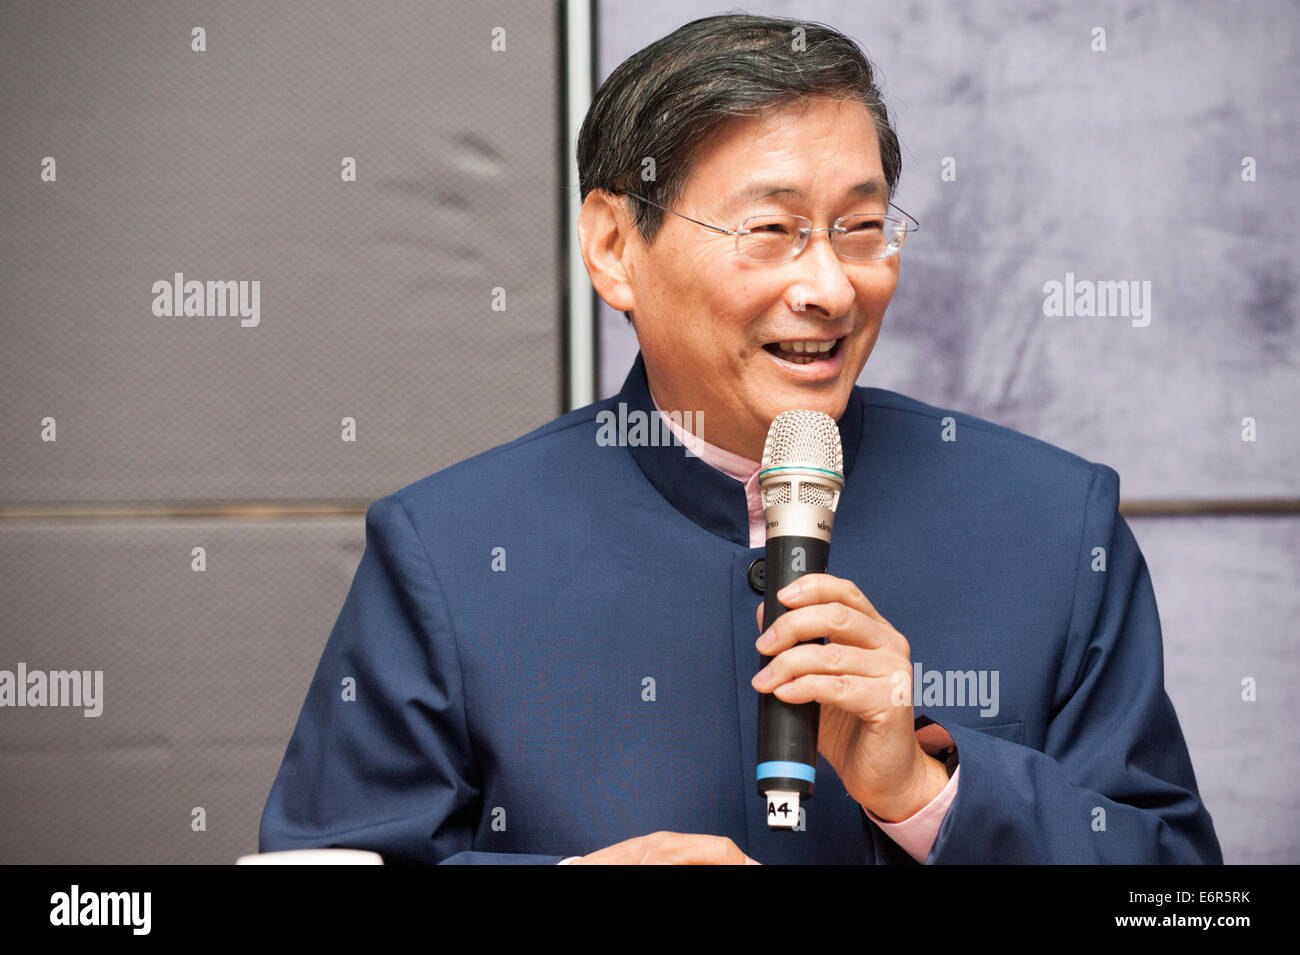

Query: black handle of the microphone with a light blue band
[[758, 535, 831, 799]]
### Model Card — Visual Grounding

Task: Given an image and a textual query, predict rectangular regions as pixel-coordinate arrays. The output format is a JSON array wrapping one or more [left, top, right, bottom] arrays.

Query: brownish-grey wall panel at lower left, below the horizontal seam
[[0, 520, 365, 864]]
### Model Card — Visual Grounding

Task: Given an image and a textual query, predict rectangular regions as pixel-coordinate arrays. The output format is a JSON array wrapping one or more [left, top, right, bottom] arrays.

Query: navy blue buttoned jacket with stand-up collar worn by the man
[[260, 355, 1222, 864]]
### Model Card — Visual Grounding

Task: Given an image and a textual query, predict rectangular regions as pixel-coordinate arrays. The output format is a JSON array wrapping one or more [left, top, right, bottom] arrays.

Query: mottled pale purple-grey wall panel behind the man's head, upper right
[[598, 0, 1300, 498]]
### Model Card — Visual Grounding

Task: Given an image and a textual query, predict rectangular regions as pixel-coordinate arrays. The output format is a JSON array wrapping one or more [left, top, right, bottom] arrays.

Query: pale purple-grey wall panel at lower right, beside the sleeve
[[1130, 517, 1300, 864]]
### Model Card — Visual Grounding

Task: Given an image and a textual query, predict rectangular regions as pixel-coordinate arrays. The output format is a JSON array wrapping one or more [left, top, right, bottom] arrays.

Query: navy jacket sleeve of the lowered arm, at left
[[259, 495, 563, 864]]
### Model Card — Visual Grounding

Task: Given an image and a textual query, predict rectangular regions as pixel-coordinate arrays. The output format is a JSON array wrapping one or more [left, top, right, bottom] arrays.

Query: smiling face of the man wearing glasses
[[625, 99, 900, 460]]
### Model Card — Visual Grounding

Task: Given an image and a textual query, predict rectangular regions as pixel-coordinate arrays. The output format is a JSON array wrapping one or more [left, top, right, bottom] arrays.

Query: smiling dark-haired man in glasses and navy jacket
[[261, 14, 1222, 864]]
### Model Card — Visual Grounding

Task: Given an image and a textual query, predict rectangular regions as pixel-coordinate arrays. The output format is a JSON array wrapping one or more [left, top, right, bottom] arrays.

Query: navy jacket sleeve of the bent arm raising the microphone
[[927, 465, 1223, 864]]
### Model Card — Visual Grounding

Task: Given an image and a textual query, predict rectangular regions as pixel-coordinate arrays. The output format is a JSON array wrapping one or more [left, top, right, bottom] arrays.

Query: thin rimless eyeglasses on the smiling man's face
[[624, 190, 920, 262]]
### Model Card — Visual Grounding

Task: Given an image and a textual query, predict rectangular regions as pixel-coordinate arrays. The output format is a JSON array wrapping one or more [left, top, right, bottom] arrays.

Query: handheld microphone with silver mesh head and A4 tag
[[758, 411, 844, 829]]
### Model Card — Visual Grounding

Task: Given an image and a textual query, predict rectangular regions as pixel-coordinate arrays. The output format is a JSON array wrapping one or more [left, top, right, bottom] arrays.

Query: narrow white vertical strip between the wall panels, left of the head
[[564, 0, 595, 411]]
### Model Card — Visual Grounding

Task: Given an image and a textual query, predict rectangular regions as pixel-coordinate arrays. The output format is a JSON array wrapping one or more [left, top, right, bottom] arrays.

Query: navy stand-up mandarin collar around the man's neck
[[612, 351, 863, 548]]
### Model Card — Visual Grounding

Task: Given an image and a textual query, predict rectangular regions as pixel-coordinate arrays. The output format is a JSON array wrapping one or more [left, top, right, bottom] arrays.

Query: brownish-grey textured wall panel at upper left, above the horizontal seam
[[0, 0, 563, 504]]
